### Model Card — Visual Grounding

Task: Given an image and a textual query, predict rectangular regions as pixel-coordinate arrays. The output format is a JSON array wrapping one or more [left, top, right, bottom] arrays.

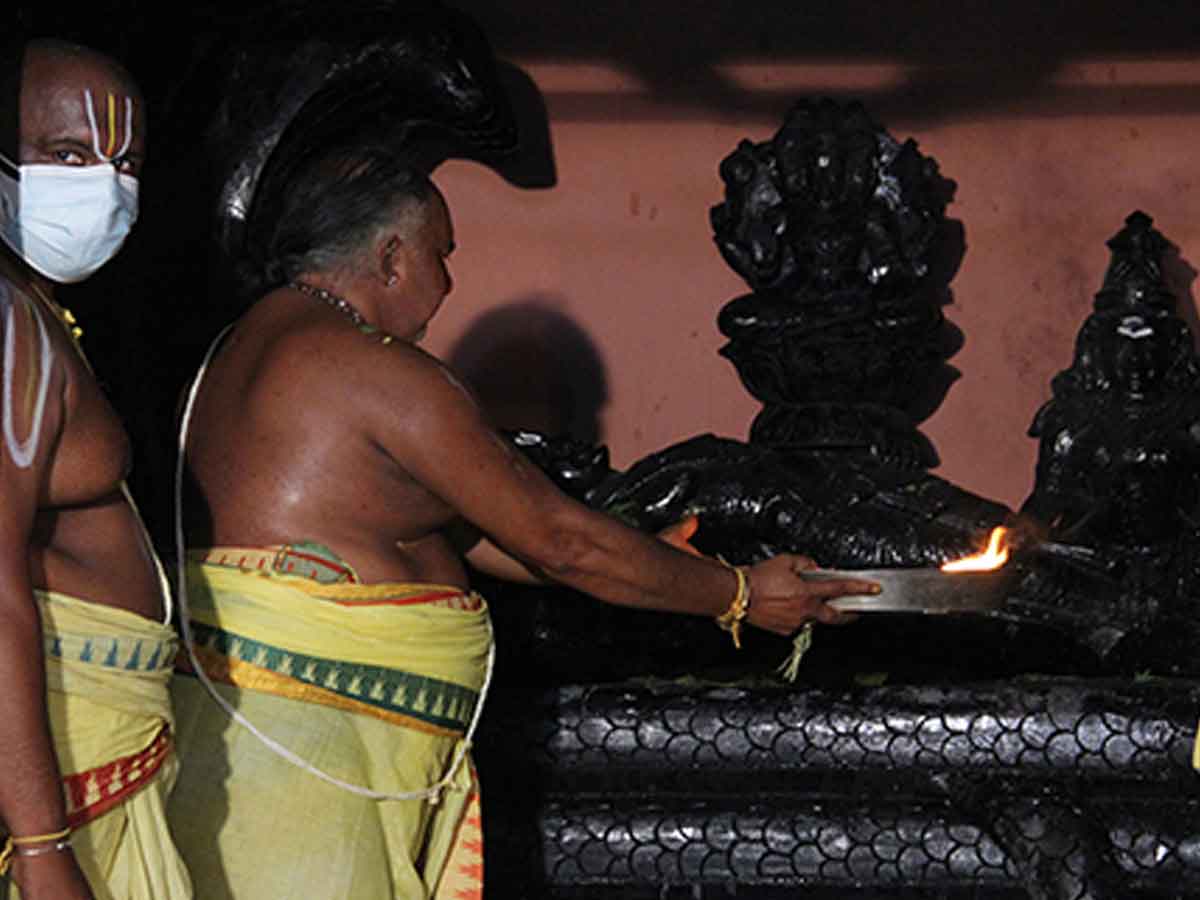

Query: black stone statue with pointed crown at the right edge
[[1009, 212, 1200, 674]]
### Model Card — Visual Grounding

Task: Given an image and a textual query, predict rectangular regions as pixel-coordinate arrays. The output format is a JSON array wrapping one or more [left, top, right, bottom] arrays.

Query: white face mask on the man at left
[[0, 157, 138, 284]]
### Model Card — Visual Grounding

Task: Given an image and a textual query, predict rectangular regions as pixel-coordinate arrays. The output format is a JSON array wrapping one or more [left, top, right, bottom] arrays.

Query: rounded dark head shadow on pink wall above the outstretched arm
[[446, 296, 608, 444]]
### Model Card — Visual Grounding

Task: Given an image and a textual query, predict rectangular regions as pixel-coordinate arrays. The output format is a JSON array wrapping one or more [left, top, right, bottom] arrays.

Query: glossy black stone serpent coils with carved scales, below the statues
[[479, 678, 1200, 900]]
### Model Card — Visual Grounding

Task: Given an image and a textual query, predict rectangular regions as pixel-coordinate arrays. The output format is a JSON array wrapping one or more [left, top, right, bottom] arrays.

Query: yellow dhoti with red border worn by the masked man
[[0, 590, 192, 900]]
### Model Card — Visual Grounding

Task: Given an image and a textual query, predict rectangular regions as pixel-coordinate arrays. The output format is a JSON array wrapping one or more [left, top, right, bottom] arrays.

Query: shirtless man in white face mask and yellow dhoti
[[0, 41, 192, 900]]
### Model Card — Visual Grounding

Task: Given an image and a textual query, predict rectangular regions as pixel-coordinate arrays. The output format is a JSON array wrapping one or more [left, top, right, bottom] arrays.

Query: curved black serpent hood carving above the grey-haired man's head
[[202, 0, 518, 301]]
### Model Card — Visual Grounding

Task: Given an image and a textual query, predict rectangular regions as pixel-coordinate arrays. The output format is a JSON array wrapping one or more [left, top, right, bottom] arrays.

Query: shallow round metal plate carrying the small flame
[[803, 569, 1013, 614]]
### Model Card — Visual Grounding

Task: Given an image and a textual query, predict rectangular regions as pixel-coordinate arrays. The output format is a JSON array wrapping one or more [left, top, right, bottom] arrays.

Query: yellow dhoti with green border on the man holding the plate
[[169, 551, 491, 900]]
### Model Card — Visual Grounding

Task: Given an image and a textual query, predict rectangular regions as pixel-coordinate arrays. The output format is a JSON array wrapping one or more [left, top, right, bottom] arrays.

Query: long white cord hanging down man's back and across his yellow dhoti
[[175, 325, 496, 803]]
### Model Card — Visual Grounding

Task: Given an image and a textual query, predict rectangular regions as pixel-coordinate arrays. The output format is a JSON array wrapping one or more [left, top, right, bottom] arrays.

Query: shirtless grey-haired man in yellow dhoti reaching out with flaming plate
[[173, 146, 871, 900]]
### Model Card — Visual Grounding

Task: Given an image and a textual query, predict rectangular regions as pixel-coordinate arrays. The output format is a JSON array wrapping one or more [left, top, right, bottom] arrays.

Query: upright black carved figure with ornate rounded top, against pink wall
[[712, 100, 952, 458]]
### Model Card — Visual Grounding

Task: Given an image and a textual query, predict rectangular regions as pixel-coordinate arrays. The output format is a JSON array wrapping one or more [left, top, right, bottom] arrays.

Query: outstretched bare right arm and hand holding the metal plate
[[362, 346, 874, 634]]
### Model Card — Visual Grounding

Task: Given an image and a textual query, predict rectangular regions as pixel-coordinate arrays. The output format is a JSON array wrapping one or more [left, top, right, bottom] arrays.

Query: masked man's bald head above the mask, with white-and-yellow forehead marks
[[16, 40, 145, 175]]
